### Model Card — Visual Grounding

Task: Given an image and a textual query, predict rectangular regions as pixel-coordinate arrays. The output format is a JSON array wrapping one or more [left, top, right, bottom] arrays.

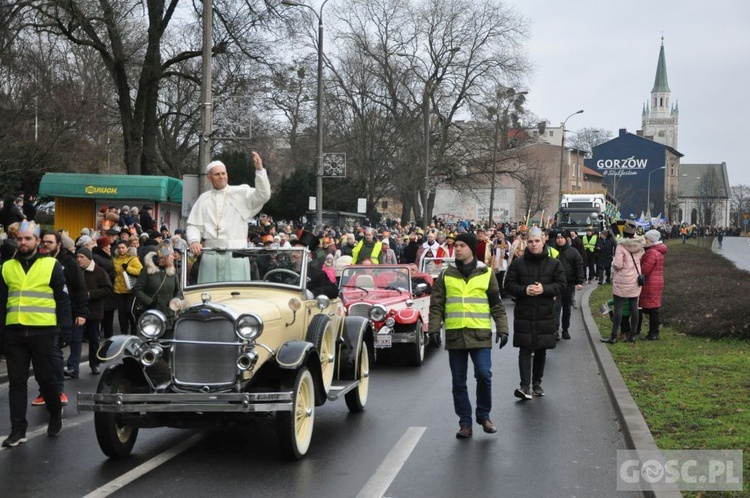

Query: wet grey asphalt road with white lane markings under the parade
[[0, 300, 640, 498]]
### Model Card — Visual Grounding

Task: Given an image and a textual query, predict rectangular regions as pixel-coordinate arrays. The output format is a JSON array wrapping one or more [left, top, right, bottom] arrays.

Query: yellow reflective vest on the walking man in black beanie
[[445, 269, 492, 329]]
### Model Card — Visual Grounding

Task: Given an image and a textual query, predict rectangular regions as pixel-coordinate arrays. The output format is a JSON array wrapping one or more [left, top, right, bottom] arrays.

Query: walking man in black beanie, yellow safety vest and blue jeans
[[429, 233, 508, 439]]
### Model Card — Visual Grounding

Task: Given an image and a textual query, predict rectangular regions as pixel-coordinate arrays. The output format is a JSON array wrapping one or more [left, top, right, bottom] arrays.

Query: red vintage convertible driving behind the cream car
[[339, 265, 441, 366]]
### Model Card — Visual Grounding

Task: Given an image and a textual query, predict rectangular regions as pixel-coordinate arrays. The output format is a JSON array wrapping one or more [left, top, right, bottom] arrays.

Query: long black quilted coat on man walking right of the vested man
[[505, 249, 575, 350]]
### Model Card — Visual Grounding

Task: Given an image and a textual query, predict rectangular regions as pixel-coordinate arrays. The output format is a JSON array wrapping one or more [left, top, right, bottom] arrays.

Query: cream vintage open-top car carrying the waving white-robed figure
[[78, 248, 374, 459]]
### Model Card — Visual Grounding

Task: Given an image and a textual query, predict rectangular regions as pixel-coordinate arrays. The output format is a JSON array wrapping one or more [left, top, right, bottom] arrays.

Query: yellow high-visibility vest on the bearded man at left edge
[[2, 257, 57, 327]]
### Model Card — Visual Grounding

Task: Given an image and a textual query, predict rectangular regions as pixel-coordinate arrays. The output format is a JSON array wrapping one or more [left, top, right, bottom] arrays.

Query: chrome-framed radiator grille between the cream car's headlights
[[172, 319, 239, 387]]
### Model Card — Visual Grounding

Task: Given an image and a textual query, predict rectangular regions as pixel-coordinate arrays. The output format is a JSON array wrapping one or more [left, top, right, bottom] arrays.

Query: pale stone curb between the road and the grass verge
[[580, 287, 682, 498]]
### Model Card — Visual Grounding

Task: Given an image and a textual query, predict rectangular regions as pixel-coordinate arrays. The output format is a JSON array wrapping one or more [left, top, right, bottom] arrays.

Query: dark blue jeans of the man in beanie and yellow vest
[[448, 348, 492, 427]]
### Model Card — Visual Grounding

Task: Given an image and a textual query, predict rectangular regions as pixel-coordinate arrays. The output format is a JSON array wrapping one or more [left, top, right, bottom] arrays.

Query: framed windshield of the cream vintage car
[[183, 247, 308, 288]]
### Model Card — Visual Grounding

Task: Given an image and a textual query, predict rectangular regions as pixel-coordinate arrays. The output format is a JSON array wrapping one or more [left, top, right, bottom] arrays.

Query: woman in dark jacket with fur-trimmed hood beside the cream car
[[133, 241, 180, 329]]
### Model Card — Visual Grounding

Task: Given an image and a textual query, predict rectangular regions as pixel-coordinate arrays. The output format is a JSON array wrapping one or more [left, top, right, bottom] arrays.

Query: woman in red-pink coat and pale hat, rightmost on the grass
[[636, 230, 667, 341]]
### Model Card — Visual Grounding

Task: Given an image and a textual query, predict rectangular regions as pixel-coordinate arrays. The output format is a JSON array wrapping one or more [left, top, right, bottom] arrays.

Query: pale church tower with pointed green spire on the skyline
[[641, 36, 679, 150]]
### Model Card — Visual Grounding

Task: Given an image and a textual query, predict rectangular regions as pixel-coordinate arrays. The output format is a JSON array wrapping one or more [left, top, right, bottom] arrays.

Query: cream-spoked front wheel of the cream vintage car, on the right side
[[276, 367, 315, 460]]
